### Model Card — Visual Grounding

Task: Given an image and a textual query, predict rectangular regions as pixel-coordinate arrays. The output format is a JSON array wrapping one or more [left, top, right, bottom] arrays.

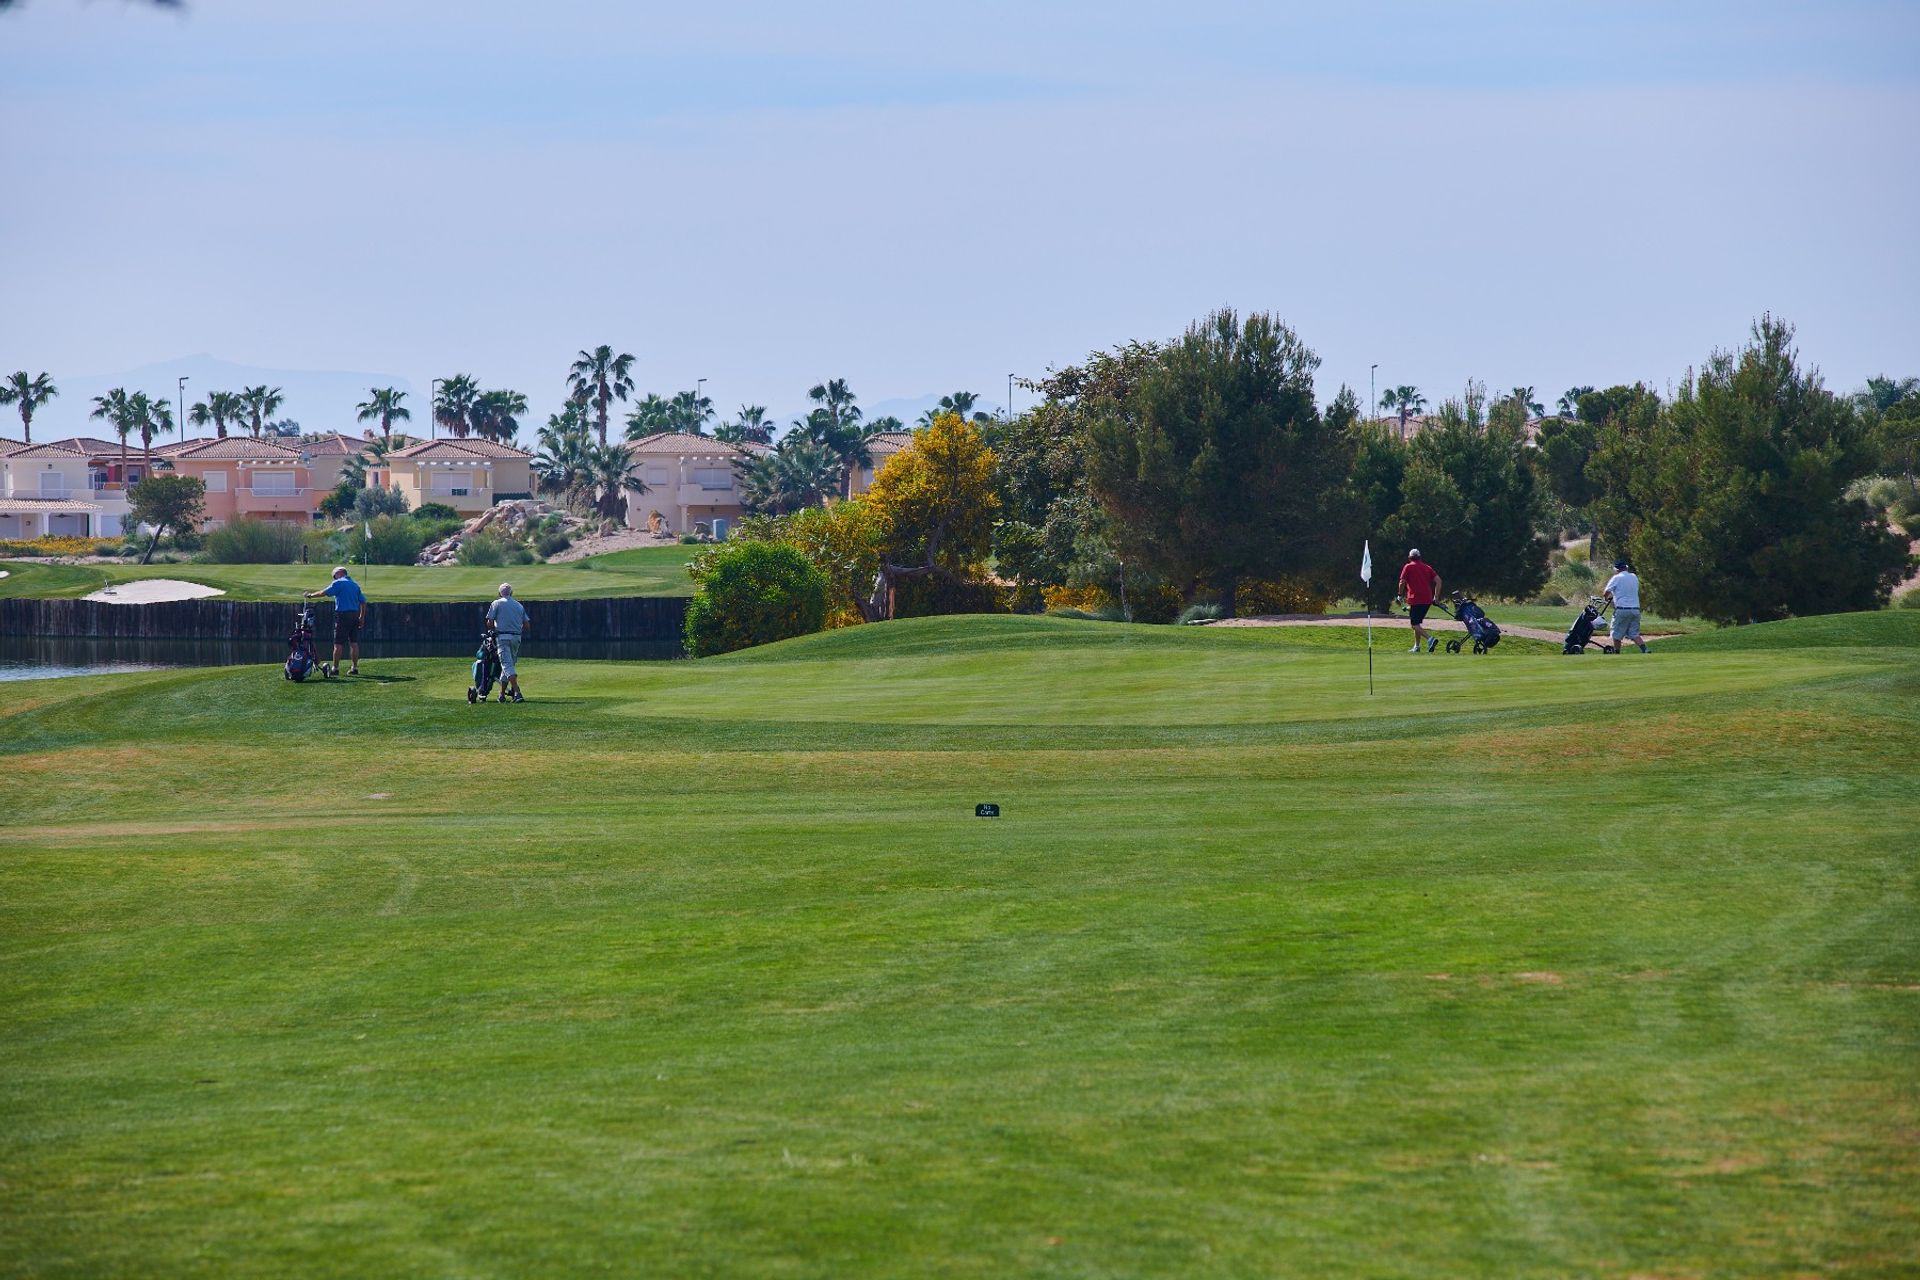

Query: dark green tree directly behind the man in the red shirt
[[1354, 382, 1551, 606]]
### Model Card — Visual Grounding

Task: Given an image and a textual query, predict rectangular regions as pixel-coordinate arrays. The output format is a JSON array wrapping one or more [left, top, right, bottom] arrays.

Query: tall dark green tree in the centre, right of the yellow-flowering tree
[[1087, 311, 1359, 616]]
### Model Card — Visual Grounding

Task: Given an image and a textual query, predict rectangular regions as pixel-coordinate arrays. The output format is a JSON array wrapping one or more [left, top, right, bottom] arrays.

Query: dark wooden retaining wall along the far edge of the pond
[[0, 595, 687, 645]]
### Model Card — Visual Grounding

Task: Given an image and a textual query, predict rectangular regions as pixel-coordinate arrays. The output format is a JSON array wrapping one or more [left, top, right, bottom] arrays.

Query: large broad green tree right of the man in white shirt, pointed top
[[1607, 315, 1912, 622]]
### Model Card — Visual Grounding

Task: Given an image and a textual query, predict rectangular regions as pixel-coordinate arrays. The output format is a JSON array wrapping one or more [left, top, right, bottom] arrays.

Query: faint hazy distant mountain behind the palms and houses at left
[[23, 355, 426, 439]]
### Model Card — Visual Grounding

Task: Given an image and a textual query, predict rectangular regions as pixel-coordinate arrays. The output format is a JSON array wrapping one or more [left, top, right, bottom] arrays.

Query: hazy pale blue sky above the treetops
[[0, 0, 1920, 435]]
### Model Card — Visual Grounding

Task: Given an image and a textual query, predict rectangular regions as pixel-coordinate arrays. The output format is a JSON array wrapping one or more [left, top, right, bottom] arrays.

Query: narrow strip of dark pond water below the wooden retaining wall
[[0, 635, 682, 681]]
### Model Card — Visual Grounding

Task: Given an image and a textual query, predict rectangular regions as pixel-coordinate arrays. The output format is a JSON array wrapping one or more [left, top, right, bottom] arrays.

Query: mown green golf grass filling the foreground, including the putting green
[[0, 610, 1920, 1278]]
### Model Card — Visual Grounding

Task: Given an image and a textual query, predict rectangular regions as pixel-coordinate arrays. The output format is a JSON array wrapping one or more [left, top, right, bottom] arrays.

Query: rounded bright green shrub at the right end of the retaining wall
[[687, 543, 828, 658]]
